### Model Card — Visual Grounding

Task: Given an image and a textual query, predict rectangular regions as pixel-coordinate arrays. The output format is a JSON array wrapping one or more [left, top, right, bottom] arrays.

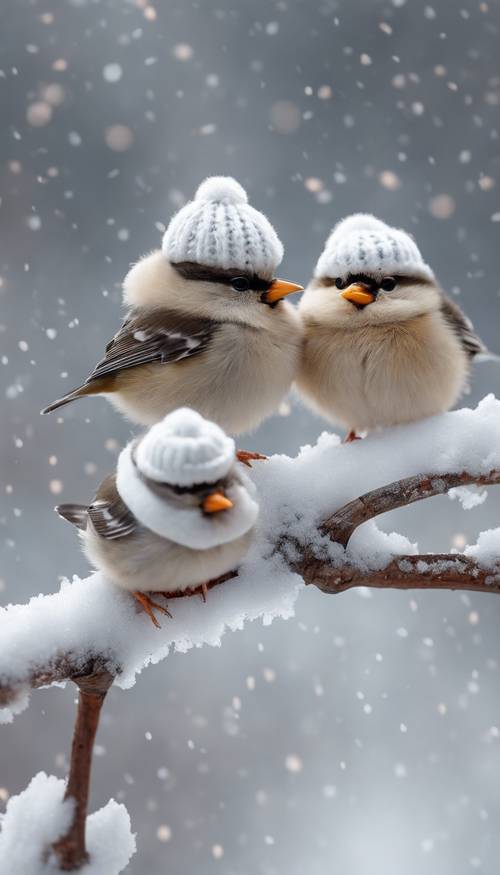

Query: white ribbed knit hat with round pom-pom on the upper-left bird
[[162, 176, 283, 278]]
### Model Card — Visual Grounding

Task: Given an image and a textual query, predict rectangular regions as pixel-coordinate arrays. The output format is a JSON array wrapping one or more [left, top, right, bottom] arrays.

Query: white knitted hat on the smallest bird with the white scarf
[[135, 407, 235, 486]]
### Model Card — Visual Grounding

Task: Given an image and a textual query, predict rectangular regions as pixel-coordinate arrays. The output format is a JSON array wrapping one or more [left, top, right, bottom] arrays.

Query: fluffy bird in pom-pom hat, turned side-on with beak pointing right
[[42, 177, 302, 442]]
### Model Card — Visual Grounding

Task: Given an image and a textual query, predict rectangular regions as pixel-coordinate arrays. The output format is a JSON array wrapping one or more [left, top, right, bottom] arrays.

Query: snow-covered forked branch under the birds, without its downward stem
[[0, 396, 500, 720]]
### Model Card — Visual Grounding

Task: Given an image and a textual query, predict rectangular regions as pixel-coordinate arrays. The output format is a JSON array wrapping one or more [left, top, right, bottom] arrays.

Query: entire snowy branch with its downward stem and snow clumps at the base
[[0, 396, 500, 875]]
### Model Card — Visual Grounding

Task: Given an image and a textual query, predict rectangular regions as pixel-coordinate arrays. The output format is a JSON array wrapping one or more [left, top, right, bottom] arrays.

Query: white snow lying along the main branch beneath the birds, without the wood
[[0, 396, 500, 720]]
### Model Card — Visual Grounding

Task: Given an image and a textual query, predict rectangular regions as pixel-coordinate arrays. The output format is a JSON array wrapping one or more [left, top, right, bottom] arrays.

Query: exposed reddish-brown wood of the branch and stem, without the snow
[[0, 470, 500, 871]]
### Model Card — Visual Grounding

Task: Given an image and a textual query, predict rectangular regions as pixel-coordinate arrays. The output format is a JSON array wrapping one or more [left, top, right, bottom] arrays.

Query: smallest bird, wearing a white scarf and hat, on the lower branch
[[56, 408, 258, 626]]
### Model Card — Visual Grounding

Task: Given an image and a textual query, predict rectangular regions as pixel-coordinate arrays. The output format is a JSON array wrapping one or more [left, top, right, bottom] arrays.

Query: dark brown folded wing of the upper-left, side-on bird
[[85, 309, 217, 384]]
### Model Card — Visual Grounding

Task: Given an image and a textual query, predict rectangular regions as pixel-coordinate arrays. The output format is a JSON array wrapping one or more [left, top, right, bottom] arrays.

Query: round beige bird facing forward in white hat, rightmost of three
[[297, 214, 494, 441]]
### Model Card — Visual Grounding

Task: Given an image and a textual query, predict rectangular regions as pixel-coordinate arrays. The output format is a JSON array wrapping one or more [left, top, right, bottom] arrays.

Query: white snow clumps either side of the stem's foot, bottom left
[[0, 772, 135, 875]]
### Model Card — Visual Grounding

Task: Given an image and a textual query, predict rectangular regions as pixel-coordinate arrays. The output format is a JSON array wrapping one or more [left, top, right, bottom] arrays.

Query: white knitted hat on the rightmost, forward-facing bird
[[314, 213, 434, 280]]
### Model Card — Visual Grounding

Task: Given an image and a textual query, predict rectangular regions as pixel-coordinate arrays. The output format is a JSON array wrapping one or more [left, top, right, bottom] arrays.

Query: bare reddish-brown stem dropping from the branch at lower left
[[52, 672, 113, 872]]
